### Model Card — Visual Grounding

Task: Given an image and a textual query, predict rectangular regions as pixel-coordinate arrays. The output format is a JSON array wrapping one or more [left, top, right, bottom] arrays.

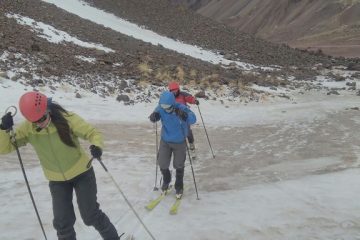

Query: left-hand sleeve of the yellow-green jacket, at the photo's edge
[[0, 123, 28, 154]]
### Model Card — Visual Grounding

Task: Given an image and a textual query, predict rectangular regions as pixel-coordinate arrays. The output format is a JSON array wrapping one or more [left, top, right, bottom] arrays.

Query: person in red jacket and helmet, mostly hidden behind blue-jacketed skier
[[168, 82, 199, 151]]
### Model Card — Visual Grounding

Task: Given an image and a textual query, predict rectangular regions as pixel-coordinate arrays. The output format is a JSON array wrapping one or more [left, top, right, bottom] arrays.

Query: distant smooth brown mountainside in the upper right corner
[[173, 0, 360, 57]]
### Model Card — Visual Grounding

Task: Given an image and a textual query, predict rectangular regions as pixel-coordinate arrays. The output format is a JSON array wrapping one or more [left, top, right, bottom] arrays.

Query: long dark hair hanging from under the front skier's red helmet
[[48, 102, 76, 147]]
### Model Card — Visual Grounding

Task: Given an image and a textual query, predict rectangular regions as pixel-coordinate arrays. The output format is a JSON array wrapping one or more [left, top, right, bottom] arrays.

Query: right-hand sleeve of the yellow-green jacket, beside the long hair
[[68, 113, 104, 148]]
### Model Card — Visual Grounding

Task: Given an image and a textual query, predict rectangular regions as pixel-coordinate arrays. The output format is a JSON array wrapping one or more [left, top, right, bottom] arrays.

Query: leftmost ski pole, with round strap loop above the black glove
[[5, 106, 47, 240]]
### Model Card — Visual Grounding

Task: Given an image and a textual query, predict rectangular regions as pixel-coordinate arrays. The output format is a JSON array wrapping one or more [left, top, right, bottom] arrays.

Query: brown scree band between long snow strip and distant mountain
[[86, 0, 344, 66]]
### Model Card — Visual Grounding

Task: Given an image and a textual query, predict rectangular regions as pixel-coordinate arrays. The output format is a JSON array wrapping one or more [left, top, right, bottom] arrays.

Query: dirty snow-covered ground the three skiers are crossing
[[0, 0, 360, 240]]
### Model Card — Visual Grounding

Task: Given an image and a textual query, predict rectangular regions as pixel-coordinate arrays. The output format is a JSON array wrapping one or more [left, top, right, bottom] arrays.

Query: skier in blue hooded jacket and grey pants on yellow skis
[[149, 91, 196, 197]]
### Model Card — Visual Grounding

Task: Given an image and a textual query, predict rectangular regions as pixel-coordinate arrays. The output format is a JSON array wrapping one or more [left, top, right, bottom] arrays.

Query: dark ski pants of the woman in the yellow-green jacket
[[49, 168, 120, 240]]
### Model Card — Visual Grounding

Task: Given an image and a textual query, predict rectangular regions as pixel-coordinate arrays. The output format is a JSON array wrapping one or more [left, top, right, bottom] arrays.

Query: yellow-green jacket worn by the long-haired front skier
[[0, 113, 104, 181]]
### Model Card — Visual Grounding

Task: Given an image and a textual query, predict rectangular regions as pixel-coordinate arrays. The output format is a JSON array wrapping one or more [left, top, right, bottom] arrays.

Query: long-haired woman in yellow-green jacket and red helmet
[[0, 92, 120, 240]]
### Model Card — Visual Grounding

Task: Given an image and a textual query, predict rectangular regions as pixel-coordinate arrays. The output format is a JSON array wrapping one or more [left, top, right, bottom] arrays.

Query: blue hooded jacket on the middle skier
[[155, 91, 196, 143]]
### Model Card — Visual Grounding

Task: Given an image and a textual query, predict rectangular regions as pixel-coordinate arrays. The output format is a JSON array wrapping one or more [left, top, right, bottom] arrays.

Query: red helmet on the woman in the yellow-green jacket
[[19, 92, 47, 122]]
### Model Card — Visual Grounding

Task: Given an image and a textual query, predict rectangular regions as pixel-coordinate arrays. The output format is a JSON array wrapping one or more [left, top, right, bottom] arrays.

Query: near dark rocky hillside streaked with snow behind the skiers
[[0, 0, 360, 104]]
